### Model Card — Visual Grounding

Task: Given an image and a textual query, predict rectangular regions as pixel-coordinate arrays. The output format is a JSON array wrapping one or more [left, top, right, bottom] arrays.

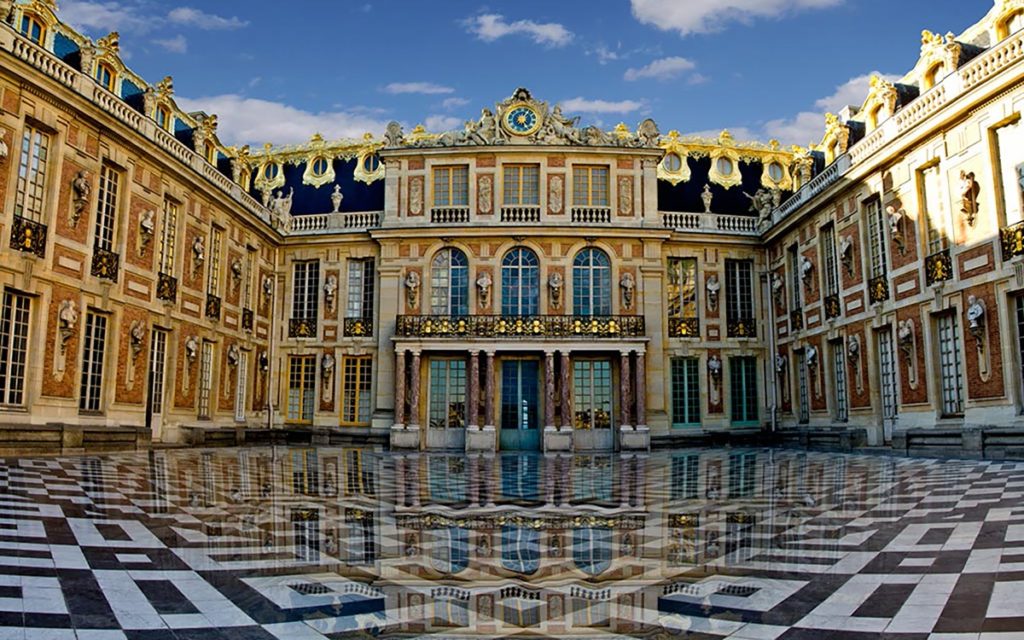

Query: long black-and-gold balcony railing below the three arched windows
[[395, 315, 645, 340]]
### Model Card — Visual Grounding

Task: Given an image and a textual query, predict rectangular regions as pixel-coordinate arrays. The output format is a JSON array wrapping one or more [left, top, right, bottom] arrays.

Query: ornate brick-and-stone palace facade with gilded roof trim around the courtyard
[[0, 0, 1024, 455]]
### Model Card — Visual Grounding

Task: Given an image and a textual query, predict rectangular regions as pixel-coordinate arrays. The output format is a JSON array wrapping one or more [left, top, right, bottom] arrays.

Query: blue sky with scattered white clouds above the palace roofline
[[59, 0, 992, 145]]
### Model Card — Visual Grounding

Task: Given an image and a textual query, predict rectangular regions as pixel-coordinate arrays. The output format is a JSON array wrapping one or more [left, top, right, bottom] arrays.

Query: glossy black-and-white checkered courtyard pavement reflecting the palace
[[0, 447, 1024, 640]]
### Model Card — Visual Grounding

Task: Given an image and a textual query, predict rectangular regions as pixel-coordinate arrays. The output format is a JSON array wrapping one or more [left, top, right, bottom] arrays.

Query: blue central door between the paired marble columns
[[501, 360, 541, 451]]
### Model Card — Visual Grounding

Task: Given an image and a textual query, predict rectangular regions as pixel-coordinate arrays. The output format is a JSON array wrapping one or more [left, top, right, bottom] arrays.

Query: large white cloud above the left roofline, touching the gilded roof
[[175, 93, 386, 146]]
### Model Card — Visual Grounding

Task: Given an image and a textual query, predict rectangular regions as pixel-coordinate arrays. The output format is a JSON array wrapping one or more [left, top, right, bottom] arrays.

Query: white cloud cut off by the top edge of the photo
[[630, 0, 844, 36]]
